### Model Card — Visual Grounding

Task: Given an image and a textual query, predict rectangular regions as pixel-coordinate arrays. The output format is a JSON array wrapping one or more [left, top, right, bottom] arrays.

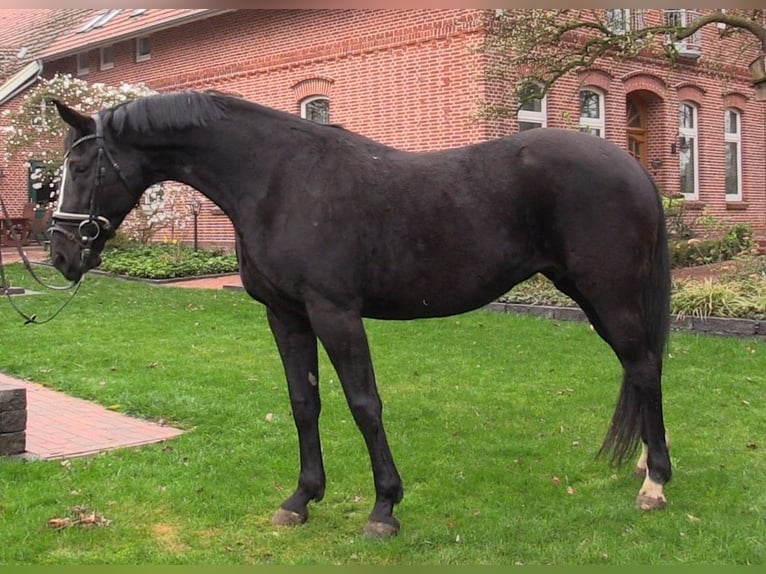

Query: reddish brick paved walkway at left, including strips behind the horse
[[0, 247, 242, 459]]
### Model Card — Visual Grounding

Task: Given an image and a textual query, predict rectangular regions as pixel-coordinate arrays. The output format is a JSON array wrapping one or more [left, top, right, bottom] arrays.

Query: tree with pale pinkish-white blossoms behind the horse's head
[[3, 74, 193, 242]]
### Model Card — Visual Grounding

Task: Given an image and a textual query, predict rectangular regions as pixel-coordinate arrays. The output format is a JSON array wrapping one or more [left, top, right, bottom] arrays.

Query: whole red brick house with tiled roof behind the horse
[[0, 9, 766, 249]]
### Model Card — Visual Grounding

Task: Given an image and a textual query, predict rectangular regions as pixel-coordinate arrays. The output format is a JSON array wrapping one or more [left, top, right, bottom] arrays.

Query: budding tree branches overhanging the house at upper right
[[483, 8, 766, 117]]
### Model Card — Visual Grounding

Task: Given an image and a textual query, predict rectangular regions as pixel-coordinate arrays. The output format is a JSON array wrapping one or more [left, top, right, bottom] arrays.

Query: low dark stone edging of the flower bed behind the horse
[[485, 301, 766, 340]]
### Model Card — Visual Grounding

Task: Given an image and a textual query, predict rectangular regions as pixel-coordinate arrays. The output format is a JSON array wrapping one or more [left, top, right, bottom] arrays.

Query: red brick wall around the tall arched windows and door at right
[[548, 37, 766, 240]]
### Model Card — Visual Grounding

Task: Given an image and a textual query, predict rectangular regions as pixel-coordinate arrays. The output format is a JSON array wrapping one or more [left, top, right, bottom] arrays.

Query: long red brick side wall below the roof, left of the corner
[[39, 10, 485, 248]]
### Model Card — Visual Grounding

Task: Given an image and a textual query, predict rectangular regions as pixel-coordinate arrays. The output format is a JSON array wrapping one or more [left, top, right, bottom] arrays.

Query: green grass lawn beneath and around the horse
[[0, 265, 766, 565]]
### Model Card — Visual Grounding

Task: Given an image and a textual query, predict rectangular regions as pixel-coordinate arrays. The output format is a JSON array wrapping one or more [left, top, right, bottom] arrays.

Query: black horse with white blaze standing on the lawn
[[51, 91, 671, 536]]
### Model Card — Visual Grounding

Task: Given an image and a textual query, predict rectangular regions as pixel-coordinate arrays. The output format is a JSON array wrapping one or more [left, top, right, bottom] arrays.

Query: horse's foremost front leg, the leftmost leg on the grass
[[268, 309, 325, 526]]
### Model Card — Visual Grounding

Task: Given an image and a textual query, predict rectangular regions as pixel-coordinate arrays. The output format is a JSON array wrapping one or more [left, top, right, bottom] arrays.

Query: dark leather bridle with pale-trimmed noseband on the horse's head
[[48, 114, 128, 261]]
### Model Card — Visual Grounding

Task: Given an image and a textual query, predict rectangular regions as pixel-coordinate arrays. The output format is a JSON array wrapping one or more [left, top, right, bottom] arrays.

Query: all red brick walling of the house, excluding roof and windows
[[3, 10, 766, 248]]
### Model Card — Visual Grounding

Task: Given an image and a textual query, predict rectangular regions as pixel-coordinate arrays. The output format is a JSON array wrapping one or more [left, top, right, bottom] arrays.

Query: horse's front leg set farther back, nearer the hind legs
[[309, 303, 404, 538]]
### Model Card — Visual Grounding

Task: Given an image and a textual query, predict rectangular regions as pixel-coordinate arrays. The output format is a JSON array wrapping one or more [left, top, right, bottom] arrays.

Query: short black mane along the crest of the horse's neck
[[103, 90, 233, 134]]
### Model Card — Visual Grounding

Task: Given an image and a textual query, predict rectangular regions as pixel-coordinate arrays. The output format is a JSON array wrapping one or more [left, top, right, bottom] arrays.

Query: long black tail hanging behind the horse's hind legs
[[599, 180, 670, 464]]
